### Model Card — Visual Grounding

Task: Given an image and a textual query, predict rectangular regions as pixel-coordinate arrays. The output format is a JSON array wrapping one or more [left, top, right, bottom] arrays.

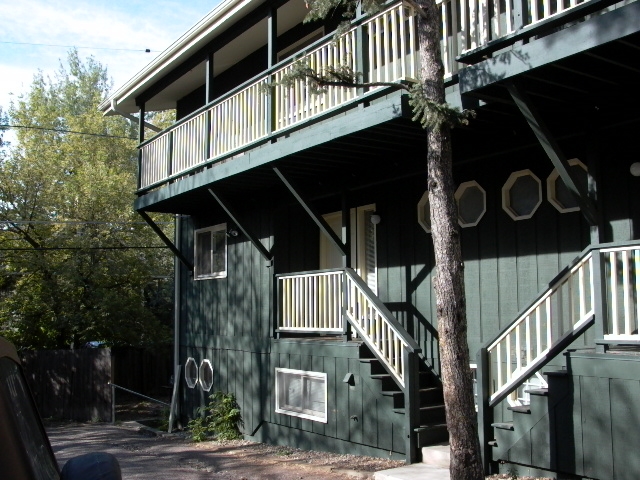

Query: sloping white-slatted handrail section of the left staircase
[[344, 268, 421, 389]]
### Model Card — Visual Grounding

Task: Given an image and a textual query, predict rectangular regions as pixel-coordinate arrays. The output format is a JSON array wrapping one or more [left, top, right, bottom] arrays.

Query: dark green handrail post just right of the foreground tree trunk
[[476, 347, 497, 475]]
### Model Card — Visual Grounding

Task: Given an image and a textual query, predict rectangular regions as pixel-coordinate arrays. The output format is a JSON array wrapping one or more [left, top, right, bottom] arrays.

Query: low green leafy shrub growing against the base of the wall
[[188, 392, 244, 442]]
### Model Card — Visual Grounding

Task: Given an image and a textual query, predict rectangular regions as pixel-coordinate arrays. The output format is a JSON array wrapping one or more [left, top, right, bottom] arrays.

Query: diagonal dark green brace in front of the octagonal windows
[[506, 81, 598, 226]]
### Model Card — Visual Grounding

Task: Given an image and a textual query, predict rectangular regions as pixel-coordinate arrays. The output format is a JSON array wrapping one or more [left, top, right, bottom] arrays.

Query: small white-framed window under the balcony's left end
[[193, 223, 227, 280]]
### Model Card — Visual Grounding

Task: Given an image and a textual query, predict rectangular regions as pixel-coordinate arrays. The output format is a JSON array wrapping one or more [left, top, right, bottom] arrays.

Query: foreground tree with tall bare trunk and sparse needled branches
[[280, 0, 484, 480]]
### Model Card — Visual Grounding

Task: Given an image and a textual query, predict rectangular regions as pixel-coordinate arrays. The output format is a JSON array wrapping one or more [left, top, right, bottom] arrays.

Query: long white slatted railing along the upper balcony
[[139, 0, 608, 189]]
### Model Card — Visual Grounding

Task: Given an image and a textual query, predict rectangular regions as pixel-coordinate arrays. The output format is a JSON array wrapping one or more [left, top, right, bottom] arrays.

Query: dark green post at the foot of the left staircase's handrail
[[402, 348, 420, 464]]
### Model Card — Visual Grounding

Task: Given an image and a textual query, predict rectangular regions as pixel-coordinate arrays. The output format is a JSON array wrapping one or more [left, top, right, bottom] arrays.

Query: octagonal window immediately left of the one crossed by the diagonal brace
[[502, 170, 542, 220]]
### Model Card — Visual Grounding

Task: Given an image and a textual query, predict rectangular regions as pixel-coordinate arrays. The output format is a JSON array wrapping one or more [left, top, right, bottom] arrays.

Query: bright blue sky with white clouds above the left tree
[[0, 0, 219, 111]]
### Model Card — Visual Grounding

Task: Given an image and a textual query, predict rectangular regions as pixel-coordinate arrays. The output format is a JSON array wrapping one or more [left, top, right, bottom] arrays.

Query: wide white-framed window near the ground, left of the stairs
[[276, 368, 327, 423]]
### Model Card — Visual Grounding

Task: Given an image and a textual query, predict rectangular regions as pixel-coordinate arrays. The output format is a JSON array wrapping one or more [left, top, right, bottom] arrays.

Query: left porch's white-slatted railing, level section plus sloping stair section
[[278, 269, 419, 388]]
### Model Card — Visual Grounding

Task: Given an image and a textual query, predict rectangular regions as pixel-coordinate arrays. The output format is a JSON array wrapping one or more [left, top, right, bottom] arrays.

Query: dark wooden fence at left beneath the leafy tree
[[22, 348, 172, 421]]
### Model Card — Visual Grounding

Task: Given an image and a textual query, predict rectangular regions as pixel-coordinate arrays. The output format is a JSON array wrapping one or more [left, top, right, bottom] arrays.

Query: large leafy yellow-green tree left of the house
[[0, 51, 172, 348]]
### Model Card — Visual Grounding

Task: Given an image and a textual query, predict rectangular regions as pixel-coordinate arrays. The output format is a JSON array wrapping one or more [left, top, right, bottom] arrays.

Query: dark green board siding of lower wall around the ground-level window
[[182, 341, 405, 458]]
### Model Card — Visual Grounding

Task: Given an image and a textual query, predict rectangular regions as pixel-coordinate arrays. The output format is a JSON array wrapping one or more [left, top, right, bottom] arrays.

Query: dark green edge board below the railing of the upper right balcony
[[459, 2, 640, 94]]
